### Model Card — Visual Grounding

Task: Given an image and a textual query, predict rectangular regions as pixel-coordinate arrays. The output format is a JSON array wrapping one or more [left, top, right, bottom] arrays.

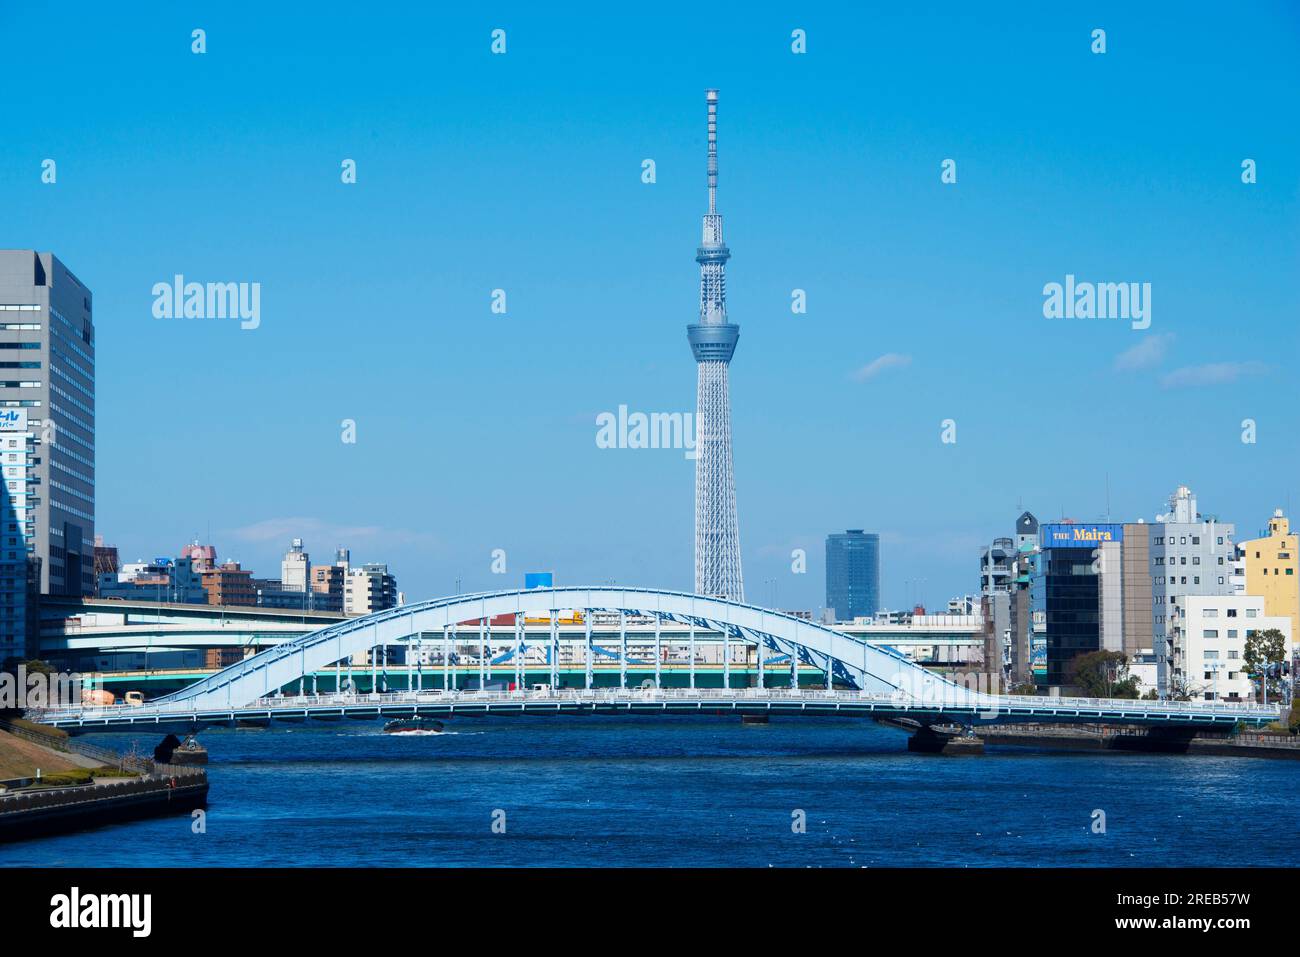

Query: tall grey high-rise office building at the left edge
[[0, 250, 95, 596]]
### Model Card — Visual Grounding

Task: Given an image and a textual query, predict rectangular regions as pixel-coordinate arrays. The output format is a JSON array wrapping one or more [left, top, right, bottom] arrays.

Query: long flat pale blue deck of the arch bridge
[[31, 688, 1279, 733]]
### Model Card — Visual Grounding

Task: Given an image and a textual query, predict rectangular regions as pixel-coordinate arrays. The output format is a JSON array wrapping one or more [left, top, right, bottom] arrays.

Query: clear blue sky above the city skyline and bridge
[[0, 3, 1300, 607]]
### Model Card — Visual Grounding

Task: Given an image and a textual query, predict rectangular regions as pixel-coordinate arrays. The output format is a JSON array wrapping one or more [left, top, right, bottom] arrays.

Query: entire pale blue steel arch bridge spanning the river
[[42, 586, 1279, 731]]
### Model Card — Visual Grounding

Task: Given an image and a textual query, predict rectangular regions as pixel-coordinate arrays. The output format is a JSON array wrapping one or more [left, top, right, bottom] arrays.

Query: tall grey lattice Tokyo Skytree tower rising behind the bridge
[[686, 90, 745, 601]]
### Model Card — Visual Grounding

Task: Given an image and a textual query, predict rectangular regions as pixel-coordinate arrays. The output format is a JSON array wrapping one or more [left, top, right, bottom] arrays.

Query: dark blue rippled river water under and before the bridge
[[0, 716, 1300, 867]]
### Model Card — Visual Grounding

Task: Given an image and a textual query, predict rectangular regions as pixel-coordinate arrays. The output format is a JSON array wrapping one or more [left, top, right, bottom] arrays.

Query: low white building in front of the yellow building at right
[[1169, 594, 1292, 701]]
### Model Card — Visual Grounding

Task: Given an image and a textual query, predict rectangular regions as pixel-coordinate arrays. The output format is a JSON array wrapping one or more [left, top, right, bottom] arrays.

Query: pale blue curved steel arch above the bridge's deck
[[156, 586, 970, 710]]
